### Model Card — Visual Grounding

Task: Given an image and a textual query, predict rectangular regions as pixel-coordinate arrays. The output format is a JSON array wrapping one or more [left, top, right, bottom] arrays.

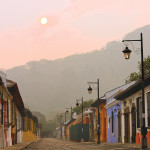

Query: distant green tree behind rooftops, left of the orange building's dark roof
[[73, 100, 93, 115]]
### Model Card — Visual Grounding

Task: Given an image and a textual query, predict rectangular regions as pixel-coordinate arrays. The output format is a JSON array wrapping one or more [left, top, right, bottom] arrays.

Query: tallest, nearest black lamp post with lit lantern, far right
[[122, 33, 147, 149]]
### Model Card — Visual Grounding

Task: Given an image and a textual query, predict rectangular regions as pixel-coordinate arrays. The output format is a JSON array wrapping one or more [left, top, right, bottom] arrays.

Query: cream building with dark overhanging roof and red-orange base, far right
[[115, 76, 150, 145]]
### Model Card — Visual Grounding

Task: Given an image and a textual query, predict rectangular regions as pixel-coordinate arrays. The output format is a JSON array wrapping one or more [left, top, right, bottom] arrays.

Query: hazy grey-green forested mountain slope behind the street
[[6, 25, 150, 116]]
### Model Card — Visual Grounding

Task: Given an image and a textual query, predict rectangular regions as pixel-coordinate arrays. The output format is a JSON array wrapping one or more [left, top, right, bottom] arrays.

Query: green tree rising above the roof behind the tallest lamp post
[[125, 55, 150, 83]]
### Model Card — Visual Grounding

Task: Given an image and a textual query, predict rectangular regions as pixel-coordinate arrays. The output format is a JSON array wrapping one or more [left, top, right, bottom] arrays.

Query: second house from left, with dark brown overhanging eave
[[7, 80, 24, 144]]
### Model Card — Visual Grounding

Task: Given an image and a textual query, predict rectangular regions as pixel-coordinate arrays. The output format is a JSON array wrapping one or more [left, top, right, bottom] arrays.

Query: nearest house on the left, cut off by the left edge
[[0, 71, 13, 148]]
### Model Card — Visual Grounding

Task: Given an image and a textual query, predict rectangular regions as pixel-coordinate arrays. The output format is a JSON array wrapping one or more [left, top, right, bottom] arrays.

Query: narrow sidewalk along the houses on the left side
[[0, 139, 40, 150]]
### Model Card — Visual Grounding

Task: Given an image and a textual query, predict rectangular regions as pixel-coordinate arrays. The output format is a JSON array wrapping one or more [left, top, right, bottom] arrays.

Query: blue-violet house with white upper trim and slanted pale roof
[[105, 82, 134, 143]]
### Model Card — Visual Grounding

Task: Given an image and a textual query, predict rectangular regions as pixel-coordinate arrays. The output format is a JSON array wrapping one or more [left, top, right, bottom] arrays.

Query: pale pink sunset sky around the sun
[[0, 0, 150, 69]]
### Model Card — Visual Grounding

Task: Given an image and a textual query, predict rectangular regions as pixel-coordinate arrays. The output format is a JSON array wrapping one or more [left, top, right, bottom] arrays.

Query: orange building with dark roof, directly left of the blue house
[[91, 98, 107, 142]]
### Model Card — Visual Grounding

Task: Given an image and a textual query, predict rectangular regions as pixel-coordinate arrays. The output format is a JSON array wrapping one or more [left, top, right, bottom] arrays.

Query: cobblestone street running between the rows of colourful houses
[[23, 138, 150, 150]]
